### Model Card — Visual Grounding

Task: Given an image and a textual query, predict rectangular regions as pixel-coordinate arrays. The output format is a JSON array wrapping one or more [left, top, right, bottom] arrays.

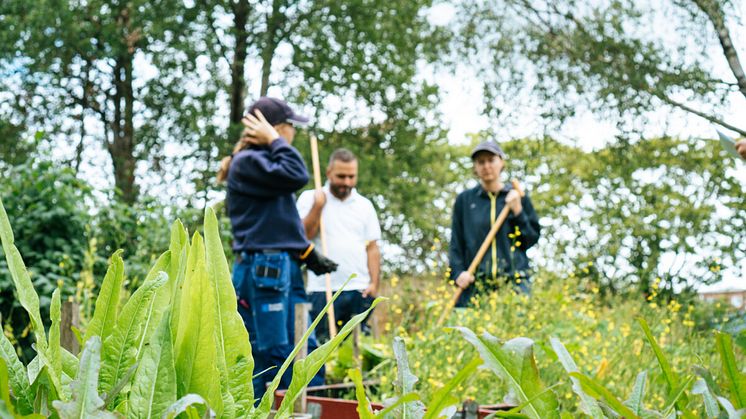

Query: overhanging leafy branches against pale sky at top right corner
[[458, 0, 746, 137]]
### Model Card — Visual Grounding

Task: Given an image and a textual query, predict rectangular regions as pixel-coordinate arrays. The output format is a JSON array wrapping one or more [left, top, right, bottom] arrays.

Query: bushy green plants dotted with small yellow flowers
[[370, 271, 744, 417]]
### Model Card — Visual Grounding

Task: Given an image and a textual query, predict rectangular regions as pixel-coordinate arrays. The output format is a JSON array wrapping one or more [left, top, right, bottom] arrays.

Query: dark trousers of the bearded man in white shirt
[[308, 290, 373, 343]]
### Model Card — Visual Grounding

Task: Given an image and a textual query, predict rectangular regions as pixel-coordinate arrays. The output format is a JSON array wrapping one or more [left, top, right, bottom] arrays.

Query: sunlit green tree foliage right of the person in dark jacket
[[494, 138, 746, 296]]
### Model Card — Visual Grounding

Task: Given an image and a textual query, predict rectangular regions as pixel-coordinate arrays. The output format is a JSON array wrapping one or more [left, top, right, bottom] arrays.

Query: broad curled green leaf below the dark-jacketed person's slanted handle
[[455, 327, 559, 419]]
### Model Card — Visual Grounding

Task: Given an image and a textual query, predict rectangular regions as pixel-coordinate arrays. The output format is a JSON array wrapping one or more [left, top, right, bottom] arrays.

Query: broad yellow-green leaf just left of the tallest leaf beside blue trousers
[[174, 233, 221, 416]]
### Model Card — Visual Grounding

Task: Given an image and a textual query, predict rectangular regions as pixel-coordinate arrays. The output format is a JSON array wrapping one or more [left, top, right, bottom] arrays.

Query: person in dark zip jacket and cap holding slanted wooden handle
[[448, 141, 541, 307]]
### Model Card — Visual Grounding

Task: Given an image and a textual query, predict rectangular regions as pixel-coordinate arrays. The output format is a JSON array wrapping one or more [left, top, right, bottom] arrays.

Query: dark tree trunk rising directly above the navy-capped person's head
[[230, 0, 250, 124]]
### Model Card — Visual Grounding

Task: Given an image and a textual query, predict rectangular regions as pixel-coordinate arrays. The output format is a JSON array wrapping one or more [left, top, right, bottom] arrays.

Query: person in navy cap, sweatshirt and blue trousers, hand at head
[[218, 97, 337, 400]]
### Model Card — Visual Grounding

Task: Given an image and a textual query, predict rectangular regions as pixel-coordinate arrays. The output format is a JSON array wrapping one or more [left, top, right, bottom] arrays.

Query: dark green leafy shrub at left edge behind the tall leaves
[[0, 162, 91, 362]]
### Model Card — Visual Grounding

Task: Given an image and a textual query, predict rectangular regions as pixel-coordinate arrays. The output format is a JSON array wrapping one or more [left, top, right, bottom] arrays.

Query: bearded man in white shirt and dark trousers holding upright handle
[[296, 148, 381, 342]]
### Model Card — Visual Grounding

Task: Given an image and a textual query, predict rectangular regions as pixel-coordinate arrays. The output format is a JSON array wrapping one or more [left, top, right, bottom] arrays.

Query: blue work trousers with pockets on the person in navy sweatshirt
[[228, 252, 323, 402]]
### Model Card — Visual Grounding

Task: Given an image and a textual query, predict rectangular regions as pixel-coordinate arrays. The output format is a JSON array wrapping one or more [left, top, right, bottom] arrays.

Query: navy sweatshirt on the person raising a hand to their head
[[226, 137, 309, 255]]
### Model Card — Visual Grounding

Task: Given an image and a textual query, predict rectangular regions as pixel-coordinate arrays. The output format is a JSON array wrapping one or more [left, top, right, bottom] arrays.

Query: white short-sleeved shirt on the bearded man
[[296, 187, 381, 292]]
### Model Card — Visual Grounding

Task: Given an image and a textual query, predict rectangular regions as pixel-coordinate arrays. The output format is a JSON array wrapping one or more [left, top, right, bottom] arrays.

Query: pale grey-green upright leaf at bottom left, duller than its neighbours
[[52, 336, 116, 419]]
